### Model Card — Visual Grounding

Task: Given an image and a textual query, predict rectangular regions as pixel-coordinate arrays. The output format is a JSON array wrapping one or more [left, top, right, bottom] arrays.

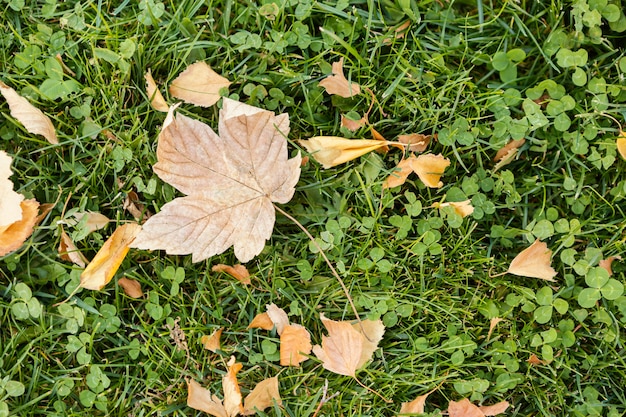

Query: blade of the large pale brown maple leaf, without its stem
[[133, 98, 301, 262]]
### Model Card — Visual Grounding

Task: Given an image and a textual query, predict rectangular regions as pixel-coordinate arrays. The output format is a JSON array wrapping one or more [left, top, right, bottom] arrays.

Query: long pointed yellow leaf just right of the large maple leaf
[[298, 136, 387, 168]]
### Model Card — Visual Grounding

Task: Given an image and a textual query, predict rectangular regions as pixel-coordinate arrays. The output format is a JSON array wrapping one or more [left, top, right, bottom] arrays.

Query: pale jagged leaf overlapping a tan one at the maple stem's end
[[313, 314, 363, 378]]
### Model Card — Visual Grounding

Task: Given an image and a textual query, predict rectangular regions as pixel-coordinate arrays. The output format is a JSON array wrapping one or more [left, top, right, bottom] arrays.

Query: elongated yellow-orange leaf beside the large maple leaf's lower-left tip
[[79, 223, 141, 290]]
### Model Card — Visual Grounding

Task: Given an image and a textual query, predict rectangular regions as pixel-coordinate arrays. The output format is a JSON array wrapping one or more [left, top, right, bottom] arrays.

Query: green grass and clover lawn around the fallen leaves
[[0, 0, 626, 417]]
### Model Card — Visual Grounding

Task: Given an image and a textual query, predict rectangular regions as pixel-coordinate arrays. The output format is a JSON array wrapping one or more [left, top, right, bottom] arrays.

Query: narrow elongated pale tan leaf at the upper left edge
[[0, 81, 59, 145]]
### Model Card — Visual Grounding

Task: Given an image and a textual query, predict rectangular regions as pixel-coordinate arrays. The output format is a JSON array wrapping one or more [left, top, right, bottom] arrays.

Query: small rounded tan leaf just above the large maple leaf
[[170, 62, 231, 107]]
